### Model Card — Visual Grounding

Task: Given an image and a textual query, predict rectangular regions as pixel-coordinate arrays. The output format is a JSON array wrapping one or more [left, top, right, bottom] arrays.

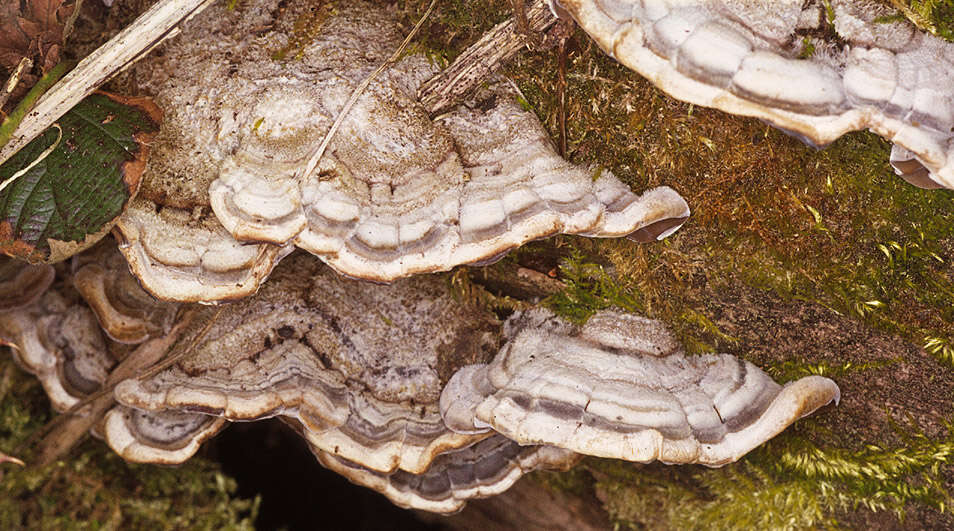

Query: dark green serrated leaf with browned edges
[[0, 94, 158, 262]]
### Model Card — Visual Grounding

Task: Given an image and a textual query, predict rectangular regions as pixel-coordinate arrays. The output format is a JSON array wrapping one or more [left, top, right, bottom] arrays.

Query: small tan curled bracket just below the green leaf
[[73, 241, 178, 344]]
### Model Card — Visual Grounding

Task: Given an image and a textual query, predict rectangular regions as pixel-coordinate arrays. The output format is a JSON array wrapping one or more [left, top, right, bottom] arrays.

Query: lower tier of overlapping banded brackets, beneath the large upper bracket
[[0, 243, 838, 513]]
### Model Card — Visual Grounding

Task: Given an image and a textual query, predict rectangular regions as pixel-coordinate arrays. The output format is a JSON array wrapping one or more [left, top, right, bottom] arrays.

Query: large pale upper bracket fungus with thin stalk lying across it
[[119, 0, 689, 300]]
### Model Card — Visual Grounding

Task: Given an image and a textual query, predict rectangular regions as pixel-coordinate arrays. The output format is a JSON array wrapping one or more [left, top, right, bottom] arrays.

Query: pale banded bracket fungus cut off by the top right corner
[[555, 0, 954, 188]]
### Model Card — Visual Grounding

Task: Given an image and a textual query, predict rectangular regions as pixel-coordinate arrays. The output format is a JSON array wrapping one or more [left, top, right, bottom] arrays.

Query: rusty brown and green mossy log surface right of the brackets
[[498, 7, 954, 528]]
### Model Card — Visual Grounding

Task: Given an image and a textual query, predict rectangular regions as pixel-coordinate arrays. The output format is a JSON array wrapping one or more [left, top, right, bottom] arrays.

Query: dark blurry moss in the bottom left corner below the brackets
[[0, 356, 258, 529]]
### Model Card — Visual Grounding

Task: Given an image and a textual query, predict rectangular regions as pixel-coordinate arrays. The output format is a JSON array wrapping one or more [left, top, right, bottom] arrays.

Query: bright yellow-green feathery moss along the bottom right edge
[[588, 432, 954, 529]]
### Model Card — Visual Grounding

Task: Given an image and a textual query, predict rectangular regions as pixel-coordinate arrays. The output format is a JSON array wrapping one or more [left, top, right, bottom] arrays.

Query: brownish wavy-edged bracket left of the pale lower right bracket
[[115, 255, 499, 472]]
